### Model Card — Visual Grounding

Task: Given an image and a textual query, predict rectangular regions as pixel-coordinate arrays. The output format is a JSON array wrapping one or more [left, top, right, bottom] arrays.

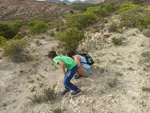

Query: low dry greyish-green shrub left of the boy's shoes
[[29, 88, 57, 103]]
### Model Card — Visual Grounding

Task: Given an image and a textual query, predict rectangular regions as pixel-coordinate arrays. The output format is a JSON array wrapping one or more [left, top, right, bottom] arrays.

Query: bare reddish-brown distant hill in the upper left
[[0, 0, 70, 21]]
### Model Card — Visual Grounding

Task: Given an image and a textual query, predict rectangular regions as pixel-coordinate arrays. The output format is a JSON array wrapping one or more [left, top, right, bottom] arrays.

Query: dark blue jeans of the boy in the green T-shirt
[[64, 66, 79, 91]]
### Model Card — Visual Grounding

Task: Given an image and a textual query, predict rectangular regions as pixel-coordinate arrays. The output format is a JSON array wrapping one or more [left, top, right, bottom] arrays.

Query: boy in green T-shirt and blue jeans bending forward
[[48, 51, 81, 96]]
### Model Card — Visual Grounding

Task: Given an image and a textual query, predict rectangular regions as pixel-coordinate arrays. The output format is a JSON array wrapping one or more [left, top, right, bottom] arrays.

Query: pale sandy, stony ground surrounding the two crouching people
[[0, 17, 150, 113]]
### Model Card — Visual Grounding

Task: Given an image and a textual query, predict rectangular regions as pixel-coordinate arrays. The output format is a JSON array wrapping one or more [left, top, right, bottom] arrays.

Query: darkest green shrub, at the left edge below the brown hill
[[0, 21, 22, 39]]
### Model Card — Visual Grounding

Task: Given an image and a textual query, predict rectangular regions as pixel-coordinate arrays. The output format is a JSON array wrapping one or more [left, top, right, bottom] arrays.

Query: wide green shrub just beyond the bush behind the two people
[[66, 13, 96, 28]]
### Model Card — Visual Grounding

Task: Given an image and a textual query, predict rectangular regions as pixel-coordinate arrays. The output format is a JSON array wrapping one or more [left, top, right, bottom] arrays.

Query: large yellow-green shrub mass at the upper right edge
[[120, 4, 150, 30]]
